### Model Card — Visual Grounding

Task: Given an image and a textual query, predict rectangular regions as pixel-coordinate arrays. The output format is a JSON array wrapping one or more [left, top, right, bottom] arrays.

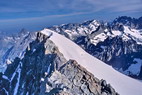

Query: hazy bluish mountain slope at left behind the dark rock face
[[0, 29, 36, 72]]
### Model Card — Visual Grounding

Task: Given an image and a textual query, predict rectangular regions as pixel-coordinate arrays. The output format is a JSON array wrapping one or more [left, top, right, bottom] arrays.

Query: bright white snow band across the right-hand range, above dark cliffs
[[91, 26, 142, 45]]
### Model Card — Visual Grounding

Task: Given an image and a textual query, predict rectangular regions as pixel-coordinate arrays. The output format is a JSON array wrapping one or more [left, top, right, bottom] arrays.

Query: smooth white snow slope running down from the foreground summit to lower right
[[41, 29, 142, 95]]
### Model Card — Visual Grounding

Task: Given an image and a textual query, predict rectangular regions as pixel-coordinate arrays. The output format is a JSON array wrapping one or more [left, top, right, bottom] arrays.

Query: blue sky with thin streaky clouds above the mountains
[[0, 0, 142, 32]]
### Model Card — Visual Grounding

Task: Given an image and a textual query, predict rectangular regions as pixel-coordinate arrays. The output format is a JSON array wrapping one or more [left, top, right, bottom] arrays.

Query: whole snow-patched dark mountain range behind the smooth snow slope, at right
[[50, 16, 142, 79]]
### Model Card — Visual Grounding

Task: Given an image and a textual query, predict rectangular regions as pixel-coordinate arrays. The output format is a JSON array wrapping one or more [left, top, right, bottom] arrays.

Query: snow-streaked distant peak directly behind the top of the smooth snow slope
[[49, 20, 101, 40]]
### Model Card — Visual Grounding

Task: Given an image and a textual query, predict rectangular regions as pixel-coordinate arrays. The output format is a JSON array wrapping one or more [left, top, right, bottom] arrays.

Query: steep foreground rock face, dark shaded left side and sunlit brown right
[[0, 32, 117, 95]]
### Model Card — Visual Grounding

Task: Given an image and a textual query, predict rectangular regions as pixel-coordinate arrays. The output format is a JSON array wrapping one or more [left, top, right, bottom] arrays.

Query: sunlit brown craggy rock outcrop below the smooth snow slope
[[47, 60, 118, 95]]
